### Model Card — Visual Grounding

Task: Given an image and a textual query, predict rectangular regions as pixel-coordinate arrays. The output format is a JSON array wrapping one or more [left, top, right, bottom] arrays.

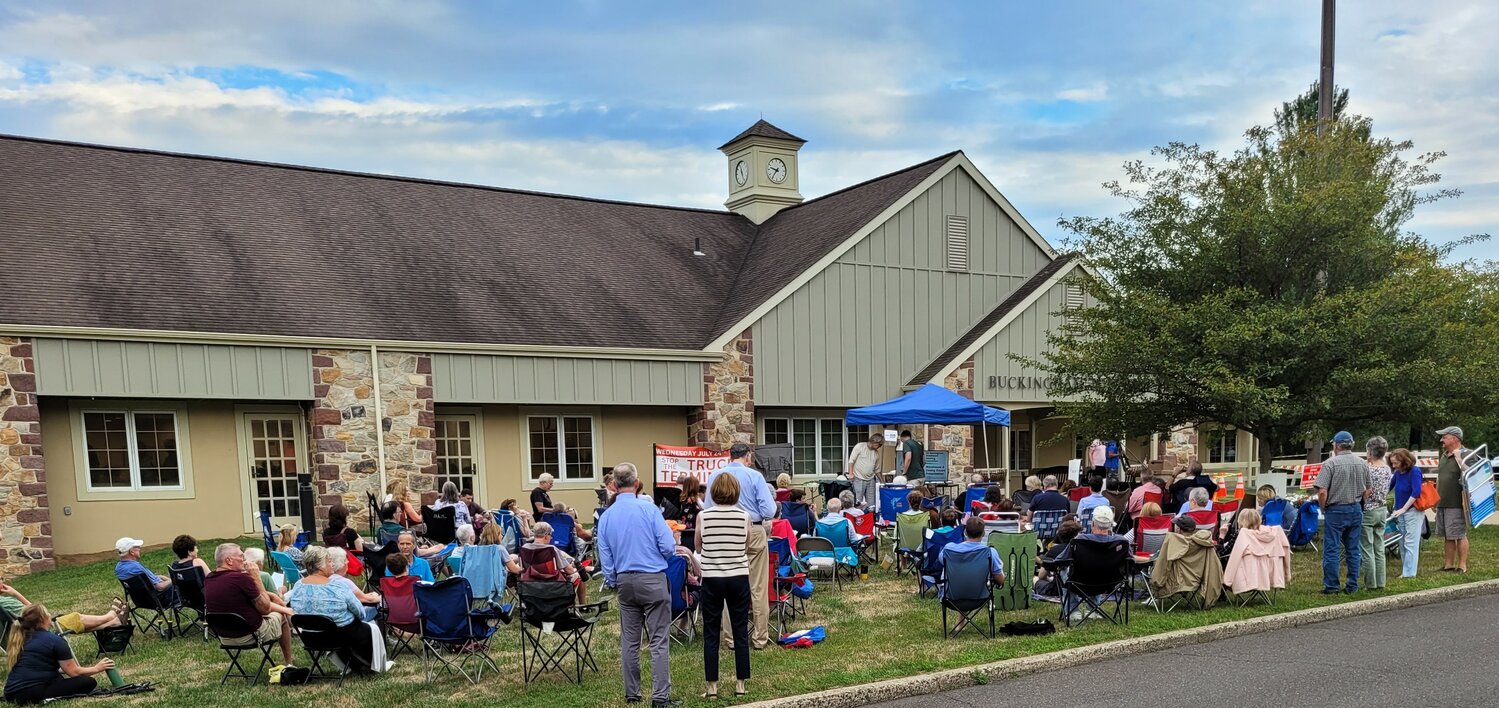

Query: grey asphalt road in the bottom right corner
[[878, 596, 1499, 708]]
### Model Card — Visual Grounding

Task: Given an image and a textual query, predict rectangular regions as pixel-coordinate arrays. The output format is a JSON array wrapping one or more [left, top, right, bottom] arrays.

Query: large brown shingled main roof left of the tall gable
[[0, 133, 946, 350]]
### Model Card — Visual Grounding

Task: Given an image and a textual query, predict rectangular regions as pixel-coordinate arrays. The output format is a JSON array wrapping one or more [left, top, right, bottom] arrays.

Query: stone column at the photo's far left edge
[[0, 338, 57, 576]]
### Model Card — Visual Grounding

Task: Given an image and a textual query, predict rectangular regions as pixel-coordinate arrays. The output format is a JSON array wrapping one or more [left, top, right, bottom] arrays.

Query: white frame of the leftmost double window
[[67, 401, 195, 501]]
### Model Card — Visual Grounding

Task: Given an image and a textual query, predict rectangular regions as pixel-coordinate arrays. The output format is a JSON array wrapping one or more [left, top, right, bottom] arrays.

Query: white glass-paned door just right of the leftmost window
[[240, 408, 307, 531]]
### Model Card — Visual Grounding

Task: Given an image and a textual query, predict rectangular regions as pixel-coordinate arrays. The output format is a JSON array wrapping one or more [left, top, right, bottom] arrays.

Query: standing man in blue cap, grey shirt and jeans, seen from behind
[[1316, 431, 1372, 596]]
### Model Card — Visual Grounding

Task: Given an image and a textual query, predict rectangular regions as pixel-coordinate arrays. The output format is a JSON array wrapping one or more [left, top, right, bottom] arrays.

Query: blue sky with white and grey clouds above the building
[[0, 0, 1499, 260]]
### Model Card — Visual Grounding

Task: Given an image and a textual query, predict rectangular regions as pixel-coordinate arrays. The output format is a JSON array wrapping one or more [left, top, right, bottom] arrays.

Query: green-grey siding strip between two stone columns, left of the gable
[[432, 354, 703, 405]]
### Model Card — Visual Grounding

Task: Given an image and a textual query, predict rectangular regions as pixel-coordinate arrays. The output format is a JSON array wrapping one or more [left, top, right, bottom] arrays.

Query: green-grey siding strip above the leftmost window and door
[[36, 339, 312, 401]]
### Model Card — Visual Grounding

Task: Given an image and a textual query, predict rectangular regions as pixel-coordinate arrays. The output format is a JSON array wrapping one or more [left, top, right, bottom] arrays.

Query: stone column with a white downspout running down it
[[312, 350, 436, 525]]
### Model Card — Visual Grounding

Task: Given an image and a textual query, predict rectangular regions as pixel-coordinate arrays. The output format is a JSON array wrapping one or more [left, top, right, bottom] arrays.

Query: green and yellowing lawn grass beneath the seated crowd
[[15, 527, 1499, 708]]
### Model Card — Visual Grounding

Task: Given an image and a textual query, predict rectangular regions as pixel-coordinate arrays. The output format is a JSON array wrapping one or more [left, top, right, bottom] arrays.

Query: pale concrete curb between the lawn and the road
[[745, 579, 1499, 708]]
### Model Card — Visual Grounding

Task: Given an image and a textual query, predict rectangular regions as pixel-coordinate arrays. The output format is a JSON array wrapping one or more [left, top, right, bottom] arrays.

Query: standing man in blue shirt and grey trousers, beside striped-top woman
[[595, 462, 680, 707]]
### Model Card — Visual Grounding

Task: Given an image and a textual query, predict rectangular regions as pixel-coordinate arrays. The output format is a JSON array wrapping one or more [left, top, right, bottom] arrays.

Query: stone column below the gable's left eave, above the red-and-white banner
[[687, 330, 754, 450]]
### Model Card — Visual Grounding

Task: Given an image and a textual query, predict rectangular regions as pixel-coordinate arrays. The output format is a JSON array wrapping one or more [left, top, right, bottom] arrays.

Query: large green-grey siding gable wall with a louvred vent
[[754, 170, 1049, 408]]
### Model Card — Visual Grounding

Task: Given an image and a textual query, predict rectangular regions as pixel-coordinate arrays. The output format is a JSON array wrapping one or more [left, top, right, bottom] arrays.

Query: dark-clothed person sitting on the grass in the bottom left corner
[[4, 605, 114, 705]]
